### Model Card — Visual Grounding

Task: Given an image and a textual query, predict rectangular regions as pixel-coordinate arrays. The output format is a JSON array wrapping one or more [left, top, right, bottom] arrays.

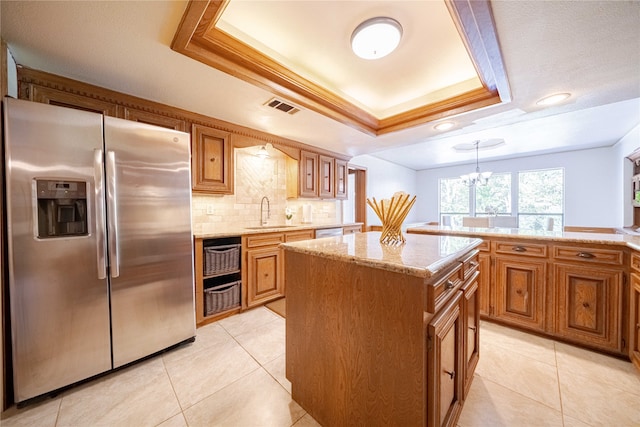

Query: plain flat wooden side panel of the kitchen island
[[285, 250, 426, 426]]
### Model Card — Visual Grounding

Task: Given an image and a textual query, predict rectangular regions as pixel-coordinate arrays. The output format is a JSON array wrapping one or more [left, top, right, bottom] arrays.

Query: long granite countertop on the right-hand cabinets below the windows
[[407, 225, 640, 250]]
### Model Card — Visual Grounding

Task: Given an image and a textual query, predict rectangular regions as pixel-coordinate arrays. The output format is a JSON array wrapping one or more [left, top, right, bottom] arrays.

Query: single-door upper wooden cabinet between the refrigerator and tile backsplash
[[191, 124, 233, 194]]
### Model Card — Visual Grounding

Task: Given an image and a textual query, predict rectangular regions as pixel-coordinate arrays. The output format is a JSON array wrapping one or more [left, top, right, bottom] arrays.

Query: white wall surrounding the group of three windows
[[416, 147, 623, 227]]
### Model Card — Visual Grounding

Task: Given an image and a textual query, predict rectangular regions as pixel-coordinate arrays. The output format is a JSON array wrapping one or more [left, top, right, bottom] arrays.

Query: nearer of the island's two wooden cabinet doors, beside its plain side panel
[[427, 291, 464, 426]]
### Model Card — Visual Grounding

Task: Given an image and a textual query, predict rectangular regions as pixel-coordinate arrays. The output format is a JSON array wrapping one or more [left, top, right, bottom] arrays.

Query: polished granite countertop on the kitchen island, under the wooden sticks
[[281, 231, 482, 278]]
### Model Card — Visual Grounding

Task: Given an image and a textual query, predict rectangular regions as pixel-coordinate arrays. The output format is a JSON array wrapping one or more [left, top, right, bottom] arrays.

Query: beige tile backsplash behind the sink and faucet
[[191, 147, 342, 234]]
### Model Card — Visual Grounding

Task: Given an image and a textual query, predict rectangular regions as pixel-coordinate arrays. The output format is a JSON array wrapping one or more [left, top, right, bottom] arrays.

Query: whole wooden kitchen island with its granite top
[[282, 232, 481, 426]]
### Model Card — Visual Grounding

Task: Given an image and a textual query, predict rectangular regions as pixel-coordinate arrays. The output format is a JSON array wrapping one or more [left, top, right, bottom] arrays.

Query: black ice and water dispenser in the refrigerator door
[[36, 179, 88, 239]]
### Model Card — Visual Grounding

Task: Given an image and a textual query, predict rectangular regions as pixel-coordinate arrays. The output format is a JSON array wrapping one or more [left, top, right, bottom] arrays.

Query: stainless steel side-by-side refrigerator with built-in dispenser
[[4, 98, 195, 402]]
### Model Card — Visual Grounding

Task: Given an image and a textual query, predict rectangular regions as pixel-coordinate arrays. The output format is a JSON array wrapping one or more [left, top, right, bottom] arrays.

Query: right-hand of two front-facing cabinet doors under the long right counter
[[554, 264, 622, 350]]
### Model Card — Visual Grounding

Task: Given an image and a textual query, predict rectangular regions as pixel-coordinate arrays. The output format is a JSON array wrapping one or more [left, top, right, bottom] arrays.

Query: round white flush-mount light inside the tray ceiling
[[351, 16, 402, 59]]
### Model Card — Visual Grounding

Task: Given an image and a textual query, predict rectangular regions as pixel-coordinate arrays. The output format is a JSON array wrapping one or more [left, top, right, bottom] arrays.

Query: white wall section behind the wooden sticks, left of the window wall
[[349, 155, 420, 225]]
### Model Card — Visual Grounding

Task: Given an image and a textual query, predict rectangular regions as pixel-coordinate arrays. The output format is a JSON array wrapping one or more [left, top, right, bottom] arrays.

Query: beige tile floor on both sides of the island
[[0, 308, 640, 427]]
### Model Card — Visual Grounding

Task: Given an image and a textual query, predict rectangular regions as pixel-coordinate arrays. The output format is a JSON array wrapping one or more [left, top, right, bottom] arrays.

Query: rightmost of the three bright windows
[[518, 169, 564, 230]]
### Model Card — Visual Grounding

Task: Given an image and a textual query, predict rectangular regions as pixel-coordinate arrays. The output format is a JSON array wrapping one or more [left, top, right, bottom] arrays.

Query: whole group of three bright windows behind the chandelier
[[440, 168, 564, 230]]
